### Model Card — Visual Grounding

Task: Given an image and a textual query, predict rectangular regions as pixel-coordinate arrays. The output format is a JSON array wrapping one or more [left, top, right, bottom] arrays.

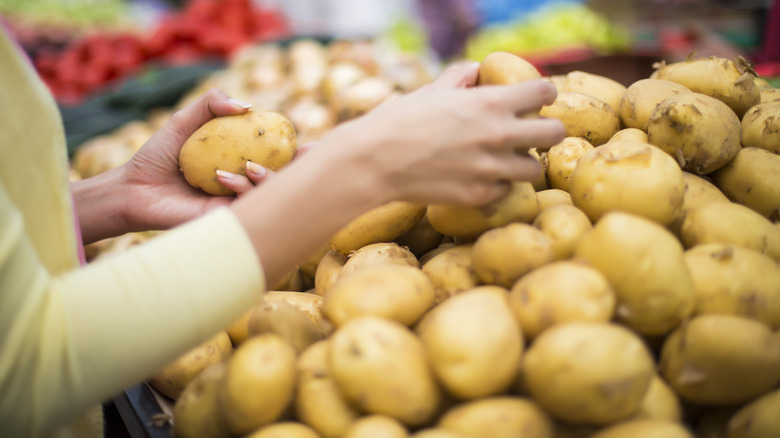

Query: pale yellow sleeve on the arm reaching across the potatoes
[[0, 184, 265, 437]]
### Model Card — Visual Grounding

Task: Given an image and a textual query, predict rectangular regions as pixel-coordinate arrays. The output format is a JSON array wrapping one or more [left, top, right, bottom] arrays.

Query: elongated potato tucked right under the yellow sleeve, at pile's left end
[[147, 330, 233, 400]]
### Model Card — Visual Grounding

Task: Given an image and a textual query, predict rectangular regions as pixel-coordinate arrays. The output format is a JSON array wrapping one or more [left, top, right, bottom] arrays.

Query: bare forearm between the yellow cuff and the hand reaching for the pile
[[231, 128, 390, 284]]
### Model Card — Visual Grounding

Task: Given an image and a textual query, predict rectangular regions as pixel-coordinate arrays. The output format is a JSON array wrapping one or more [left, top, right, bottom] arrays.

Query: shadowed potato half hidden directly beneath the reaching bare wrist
[[330, 201, 426, 255]]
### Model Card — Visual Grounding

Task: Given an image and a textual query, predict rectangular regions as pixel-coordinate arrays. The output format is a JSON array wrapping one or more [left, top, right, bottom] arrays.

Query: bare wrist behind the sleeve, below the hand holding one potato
[[70, 166, 127, 245]]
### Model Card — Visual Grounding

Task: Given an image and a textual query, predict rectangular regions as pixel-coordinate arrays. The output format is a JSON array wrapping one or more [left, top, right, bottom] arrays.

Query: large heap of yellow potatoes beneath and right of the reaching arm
[[79, 48, 780, 438]]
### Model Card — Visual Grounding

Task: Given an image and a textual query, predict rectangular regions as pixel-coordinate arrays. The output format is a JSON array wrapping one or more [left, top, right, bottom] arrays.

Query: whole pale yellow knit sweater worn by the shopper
[[0, 27, 265, 437]]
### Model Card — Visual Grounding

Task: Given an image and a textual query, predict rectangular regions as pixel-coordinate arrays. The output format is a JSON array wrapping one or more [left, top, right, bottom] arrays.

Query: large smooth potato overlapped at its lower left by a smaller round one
[[574, 212, 695, 335]]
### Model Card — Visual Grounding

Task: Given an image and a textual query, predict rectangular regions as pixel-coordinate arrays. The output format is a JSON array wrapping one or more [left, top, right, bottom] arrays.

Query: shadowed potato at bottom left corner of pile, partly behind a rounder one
[[173, 362, 232, 438]]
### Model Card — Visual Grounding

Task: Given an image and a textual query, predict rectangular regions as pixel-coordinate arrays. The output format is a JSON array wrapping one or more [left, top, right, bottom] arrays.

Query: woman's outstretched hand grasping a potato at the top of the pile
[[302, 61, 565, 209]]
